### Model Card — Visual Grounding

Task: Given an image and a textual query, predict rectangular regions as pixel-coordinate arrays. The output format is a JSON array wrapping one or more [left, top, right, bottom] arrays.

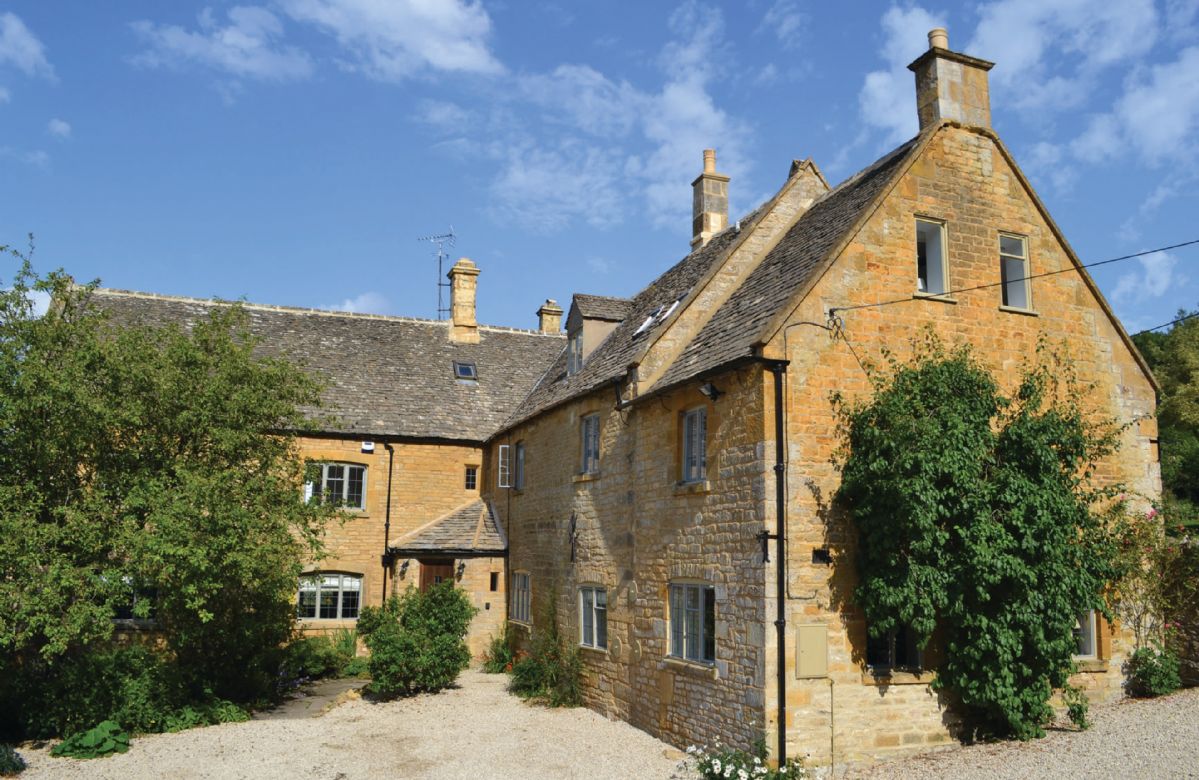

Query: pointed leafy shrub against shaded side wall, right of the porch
[[508, 594, 583, 707]]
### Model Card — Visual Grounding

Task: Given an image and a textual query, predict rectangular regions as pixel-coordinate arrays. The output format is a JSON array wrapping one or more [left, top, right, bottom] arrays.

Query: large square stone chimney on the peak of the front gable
[[908, 28, 995, 129]]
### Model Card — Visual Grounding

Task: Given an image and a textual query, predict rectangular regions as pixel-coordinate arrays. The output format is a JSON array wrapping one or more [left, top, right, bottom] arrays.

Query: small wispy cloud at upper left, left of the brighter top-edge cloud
[[132, 6, 313, 81]]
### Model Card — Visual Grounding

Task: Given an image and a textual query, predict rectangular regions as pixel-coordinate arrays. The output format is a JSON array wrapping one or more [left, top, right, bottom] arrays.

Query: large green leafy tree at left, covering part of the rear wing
[[0, 248, 333, 718]]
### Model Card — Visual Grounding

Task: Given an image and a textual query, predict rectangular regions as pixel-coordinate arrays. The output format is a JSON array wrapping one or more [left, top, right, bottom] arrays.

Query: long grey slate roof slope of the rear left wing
[[91, 289, 565, 442]]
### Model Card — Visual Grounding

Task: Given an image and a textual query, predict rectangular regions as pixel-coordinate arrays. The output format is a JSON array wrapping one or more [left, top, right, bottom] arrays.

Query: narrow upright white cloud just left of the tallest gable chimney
[[857, 6, 945, 145]]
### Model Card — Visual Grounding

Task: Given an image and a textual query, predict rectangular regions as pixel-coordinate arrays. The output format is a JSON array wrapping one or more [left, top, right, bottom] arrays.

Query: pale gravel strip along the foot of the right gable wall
[[838, 688, 1199, 780]]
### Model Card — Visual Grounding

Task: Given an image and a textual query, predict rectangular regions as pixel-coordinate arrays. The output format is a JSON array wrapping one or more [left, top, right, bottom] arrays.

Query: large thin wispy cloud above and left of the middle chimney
[[481, 2, 749, 231]]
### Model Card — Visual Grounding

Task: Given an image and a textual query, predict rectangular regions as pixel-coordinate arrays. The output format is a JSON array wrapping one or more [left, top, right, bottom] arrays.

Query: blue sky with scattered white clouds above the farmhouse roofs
[[0, 0, 1199, 331]]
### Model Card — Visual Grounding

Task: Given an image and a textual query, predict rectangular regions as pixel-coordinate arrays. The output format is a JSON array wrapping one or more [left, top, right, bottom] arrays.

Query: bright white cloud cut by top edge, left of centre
[[282, 0, 504, 81]]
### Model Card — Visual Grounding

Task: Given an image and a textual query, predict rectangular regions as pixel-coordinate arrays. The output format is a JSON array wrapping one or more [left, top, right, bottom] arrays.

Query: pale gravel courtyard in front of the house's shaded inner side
[[20, 671, 682, 780]]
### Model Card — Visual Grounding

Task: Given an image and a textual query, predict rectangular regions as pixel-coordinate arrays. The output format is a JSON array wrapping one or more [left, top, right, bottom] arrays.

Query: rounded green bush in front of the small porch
[[359, 582, 477, 699]]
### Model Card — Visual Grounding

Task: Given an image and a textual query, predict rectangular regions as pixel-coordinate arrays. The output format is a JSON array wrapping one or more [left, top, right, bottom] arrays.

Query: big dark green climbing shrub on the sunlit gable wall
[[836, 335, 1123, 739]]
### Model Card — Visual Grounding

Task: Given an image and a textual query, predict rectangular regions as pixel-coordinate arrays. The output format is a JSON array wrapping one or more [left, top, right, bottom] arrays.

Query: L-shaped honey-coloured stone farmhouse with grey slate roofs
[[96, 30, 1159, 763]]
